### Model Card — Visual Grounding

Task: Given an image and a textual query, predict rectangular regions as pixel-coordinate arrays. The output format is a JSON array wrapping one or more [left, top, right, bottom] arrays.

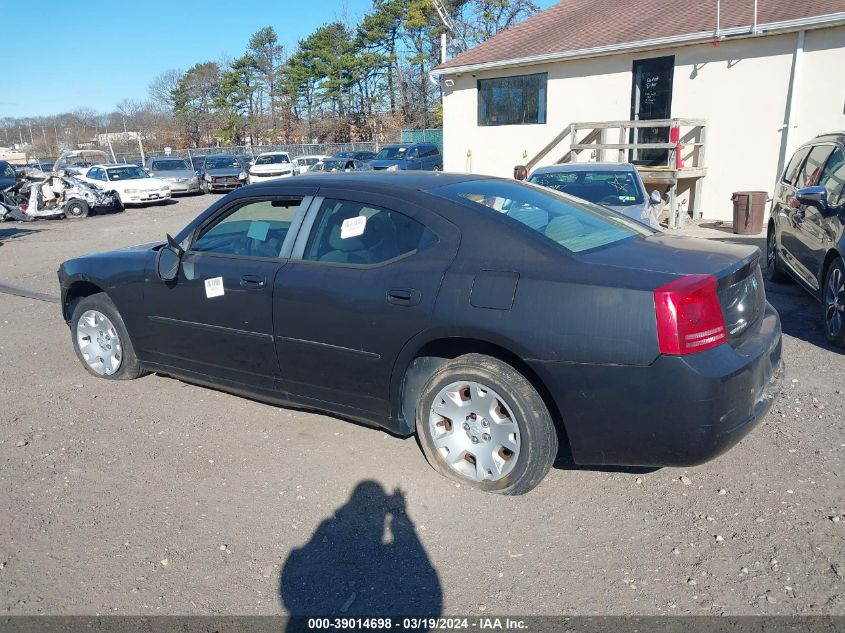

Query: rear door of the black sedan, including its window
[[273, 189, 460, 417]]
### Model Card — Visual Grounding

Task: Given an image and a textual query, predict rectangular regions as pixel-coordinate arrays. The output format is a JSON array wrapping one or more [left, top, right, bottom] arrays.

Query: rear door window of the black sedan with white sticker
[[303, 199, 437, 265]]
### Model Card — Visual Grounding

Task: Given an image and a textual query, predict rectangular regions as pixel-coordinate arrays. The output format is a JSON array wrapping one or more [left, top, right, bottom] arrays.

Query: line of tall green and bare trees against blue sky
[[0, 0, 539, 155]]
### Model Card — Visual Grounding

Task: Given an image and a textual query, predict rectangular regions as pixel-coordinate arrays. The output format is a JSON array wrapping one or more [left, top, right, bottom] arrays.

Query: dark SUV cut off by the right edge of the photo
[[766, 132, 845, 347]]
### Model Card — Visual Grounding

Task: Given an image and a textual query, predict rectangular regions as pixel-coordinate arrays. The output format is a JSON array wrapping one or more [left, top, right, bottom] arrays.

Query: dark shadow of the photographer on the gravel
[[279, 480, 443, 631]]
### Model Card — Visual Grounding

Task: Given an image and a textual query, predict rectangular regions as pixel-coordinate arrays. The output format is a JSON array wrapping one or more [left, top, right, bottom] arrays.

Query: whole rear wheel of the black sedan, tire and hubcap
[[416, 354, 557, 495]]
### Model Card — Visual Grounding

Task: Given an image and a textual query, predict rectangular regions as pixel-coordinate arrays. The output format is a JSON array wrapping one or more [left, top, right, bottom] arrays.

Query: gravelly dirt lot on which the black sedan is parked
[[0, 196, 845, 615]]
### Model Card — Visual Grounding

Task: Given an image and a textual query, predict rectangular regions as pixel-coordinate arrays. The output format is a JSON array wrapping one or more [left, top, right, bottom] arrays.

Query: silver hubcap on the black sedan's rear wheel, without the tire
[[428, 381, 520, 481]]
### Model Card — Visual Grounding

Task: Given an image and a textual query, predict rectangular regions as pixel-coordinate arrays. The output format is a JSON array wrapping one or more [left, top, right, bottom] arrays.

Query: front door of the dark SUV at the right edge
[[790, 143, 835, 289]]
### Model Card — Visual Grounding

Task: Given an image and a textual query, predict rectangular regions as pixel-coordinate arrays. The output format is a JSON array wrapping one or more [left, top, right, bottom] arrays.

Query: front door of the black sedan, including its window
[[139, 194, 310, 390]]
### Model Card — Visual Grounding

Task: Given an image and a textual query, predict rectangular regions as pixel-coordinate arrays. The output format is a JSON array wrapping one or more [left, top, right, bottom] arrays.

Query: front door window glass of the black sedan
[[191, 198, 302, 258]]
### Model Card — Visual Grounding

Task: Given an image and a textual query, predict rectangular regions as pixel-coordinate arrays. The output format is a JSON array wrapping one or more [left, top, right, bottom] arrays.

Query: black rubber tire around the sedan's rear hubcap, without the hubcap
[[416, 354, 558, 495]]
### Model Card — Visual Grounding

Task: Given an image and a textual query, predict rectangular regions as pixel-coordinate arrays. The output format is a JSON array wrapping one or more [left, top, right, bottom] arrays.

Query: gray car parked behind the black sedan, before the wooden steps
[[528, 163, 662, 229]]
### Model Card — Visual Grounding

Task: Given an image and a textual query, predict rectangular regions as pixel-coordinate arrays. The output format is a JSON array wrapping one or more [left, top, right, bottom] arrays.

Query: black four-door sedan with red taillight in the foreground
[[59, 172, 782, 494]]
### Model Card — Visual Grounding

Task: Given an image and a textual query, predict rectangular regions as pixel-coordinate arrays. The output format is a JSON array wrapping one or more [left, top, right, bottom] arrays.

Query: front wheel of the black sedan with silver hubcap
[[70, 293, 143, 380]]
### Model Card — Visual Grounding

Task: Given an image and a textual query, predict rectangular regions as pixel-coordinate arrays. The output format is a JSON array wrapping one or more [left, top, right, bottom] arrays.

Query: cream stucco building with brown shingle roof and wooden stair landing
[[433, 0, 845, 219]]
